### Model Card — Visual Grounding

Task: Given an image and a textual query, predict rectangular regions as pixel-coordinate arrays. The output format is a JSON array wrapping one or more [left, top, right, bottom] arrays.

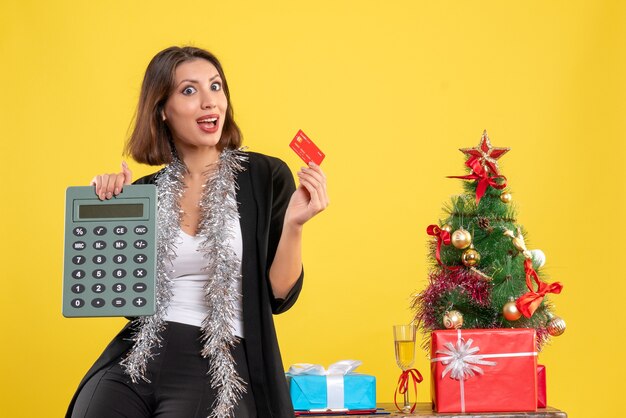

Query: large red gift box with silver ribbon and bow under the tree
[[430, 328, 537, 412]]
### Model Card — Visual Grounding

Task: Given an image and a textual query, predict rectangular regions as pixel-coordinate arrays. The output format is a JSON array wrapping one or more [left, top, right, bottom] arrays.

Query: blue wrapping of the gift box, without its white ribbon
[[287, 373, 376, 411]]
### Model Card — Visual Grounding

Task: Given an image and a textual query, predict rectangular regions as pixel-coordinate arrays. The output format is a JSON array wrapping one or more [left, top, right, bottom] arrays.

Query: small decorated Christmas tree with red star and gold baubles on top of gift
[[413, 131, 565, 347]]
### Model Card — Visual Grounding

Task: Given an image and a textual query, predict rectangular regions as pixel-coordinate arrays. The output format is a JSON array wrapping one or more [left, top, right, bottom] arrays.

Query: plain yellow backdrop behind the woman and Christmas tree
[[0, 0, 626, 418]]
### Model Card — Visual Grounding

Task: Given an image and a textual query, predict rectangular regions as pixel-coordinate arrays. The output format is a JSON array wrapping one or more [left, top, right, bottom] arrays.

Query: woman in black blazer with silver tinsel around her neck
[[67, 47, 328, 418]]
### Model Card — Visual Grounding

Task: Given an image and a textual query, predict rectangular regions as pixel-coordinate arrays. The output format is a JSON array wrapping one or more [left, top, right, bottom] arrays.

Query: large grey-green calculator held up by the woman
[[63, 186, 156, 317]]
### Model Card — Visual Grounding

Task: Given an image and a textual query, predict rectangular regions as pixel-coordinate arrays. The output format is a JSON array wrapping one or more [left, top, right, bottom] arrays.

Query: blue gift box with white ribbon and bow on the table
[[286, 360, 376, 411]]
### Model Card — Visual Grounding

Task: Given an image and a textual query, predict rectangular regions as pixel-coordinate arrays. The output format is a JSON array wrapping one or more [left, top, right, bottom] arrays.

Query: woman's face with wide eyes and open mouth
[[162, 59, 228, 154]]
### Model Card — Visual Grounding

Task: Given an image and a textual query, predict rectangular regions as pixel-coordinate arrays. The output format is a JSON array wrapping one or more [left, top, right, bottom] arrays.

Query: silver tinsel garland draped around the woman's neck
[[120, 150, 248, 418]]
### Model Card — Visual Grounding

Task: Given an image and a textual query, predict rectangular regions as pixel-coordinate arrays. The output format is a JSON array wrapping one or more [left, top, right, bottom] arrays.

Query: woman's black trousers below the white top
[[72, 322, 257, 418]]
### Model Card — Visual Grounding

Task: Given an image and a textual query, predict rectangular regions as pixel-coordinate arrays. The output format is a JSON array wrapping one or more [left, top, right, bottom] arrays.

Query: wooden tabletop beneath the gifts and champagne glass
[[302, 402, 567, 418]]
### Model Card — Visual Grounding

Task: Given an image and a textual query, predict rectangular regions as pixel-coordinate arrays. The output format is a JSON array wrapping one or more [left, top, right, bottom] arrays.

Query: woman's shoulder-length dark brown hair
[[124, 46, 242, 165]]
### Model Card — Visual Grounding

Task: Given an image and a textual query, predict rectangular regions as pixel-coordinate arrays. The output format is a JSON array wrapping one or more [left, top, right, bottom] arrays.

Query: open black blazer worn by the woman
[[66, 152, 304, 418]]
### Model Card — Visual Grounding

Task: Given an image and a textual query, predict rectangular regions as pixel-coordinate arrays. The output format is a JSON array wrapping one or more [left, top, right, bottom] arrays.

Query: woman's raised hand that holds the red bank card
[[285, 162, 329, 226]]
